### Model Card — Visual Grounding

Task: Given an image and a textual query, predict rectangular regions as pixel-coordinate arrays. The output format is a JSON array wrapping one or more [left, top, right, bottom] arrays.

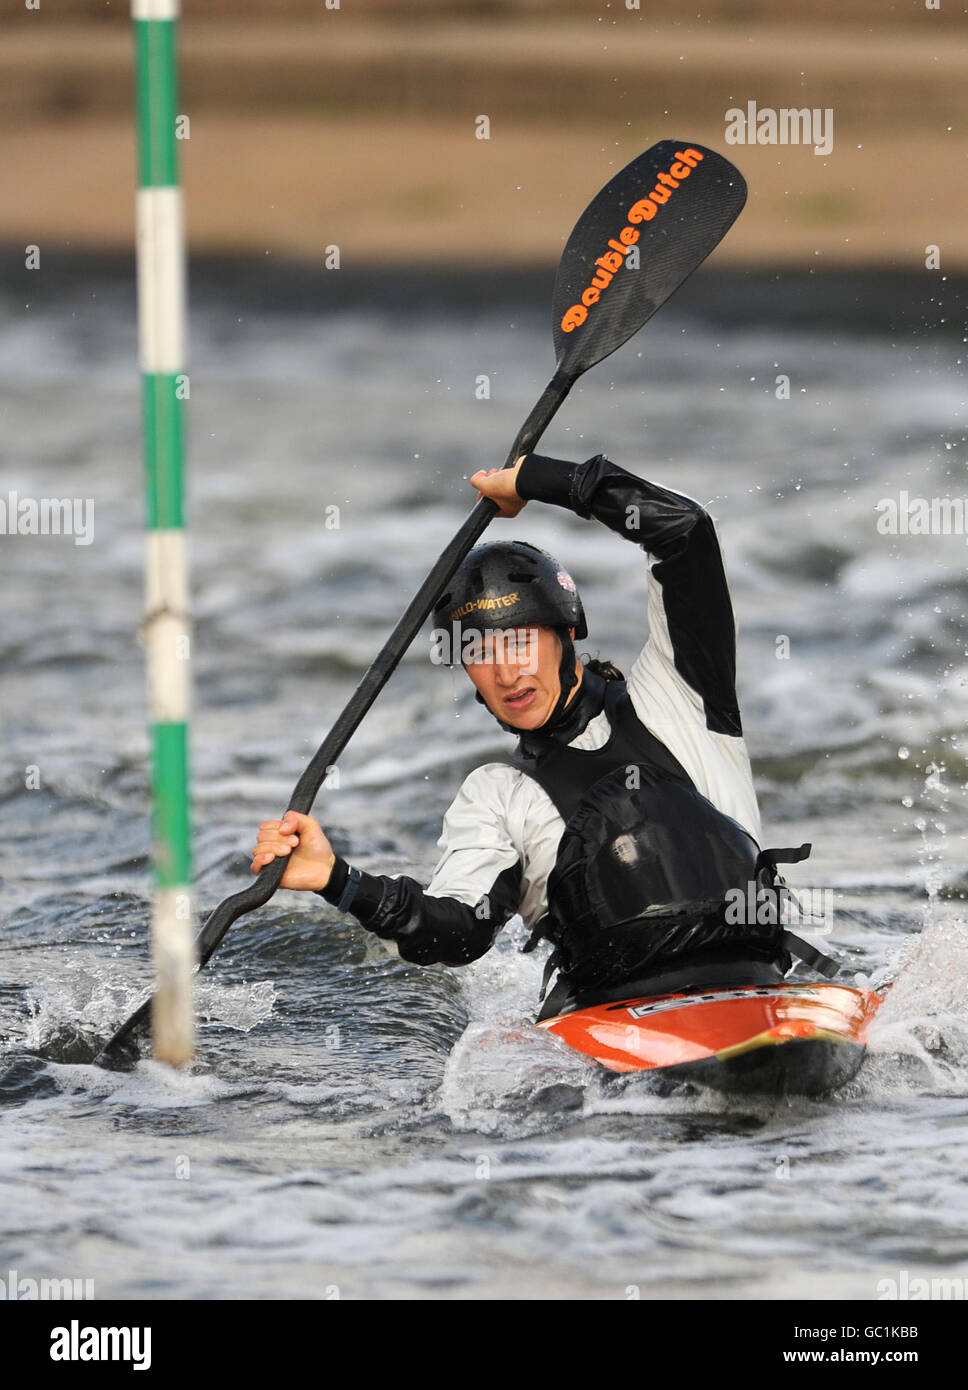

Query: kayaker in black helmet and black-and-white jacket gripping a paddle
[[252, 453, 823, 1017]]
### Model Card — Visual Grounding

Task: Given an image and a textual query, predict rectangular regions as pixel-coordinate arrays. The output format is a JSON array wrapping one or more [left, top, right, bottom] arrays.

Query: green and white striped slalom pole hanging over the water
[[131, 0, 195, 1065]]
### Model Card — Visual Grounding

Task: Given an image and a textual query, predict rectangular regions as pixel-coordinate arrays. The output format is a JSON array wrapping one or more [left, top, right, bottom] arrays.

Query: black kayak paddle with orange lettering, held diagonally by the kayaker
[[96, 140, 747, 1068]]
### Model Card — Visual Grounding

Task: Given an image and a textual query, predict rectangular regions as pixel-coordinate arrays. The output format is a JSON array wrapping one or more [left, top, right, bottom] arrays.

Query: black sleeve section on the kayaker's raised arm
[[517, 453, 743, 737]]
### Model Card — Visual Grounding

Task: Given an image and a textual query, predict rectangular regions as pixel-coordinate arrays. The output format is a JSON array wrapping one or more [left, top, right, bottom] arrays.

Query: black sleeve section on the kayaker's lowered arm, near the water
[[320, 856, 522, 965]]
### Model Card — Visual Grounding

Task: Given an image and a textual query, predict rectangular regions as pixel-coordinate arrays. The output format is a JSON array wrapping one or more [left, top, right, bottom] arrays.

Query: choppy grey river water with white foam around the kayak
[[0, 265, 968, 1298]]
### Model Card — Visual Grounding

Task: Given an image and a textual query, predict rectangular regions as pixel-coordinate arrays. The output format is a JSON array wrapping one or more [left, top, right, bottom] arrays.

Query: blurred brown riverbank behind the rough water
[[0, 0, 968, 266]]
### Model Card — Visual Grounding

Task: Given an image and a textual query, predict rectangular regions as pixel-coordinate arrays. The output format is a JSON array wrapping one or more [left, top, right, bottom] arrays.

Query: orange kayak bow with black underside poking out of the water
[[541, 981, 883, 1095]]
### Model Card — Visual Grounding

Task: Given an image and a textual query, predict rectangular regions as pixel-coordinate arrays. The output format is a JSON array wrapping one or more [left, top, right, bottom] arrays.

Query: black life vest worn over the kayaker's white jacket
[[513, 680, 828, 1016]]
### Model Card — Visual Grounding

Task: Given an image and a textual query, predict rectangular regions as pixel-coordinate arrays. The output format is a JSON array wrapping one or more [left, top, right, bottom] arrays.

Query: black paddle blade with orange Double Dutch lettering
[[552, 140, 747, 377]]
